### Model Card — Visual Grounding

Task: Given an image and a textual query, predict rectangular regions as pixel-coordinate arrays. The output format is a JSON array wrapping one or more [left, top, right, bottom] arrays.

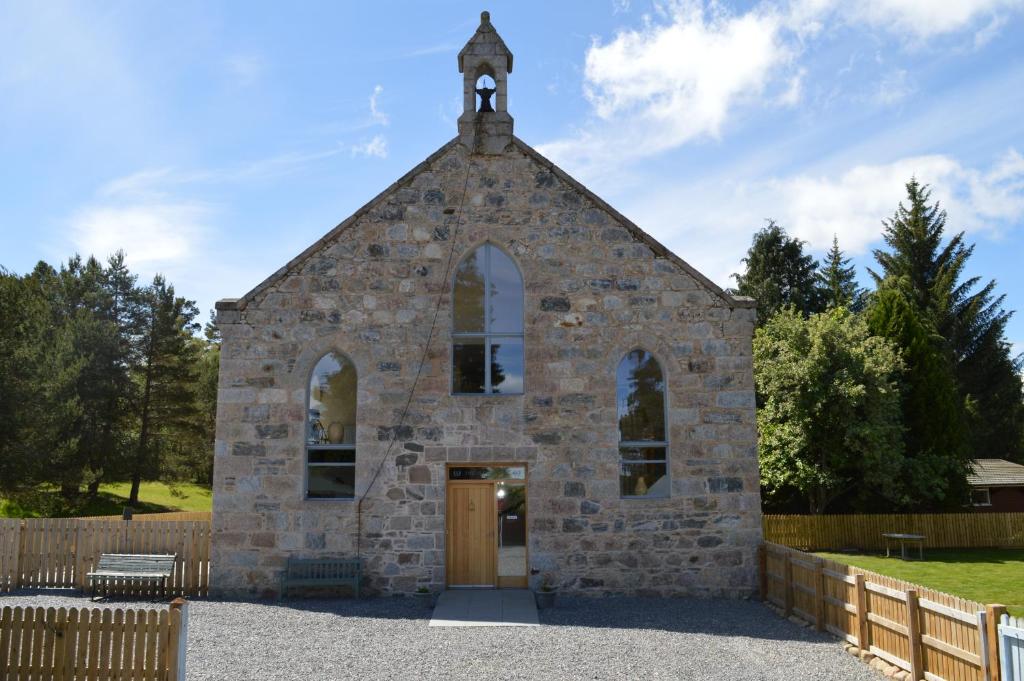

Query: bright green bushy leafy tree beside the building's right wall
[[754, 307, 903, 513]]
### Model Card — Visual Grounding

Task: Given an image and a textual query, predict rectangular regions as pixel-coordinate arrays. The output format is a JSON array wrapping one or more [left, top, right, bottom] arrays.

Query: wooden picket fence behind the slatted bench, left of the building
[[0, 518, 211, 596]]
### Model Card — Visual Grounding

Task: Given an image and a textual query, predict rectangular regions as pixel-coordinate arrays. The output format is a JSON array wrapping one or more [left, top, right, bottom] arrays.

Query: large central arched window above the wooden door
[[452, 244, 523, 394]]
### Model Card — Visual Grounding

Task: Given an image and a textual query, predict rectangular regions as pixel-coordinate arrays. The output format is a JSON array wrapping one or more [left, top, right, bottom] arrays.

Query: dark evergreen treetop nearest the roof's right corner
[[733, 220, 822, 326]]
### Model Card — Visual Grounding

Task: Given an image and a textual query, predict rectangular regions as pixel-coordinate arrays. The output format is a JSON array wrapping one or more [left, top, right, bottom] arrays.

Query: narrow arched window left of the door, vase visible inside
[[306, 352, 356, 499]]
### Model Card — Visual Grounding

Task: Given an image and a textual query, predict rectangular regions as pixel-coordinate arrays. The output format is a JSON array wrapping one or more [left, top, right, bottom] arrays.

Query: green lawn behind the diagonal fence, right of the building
[[817, 549, 1024, 616]]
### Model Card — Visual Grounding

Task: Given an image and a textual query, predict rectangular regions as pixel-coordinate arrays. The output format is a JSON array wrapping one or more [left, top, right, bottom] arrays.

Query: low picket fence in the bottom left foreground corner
[[0, 600, 188, 681]]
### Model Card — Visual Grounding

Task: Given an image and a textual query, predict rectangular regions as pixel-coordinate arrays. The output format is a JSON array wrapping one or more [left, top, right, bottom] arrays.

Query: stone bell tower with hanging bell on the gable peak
[[459, 11, 512, 154]]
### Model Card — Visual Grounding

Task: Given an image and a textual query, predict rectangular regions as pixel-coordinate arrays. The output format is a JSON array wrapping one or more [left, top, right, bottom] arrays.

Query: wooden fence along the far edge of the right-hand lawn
[[762, 513, 1024, 551]]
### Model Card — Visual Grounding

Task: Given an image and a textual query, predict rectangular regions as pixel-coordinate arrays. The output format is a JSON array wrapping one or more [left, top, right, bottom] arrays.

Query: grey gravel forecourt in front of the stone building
[[0, 592, 882, 681]]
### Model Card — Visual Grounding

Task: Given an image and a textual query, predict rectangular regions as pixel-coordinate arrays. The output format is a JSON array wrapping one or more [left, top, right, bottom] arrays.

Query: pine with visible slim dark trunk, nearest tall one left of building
[[128, 274, 200, 504]]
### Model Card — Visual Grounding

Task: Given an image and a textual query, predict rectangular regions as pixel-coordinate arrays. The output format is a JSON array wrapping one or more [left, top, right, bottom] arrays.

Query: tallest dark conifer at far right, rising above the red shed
[[871, 178, 1024, 459]]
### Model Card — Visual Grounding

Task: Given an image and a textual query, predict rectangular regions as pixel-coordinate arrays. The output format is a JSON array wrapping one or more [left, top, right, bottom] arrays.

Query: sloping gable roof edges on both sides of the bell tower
[[216, 136, 755, 310]]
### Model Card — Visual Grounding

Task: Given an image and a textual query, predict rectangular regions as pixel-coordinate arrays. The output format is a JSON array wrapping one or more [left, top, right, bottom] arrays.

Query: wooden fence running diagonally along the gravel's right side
[[761, 544, 1006, 681]]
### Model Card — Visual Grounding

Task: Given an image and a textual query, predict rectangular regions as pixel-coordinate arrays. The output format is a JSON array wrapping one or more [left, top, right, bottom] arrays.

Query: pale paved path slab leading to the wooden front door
[[430, 589, 540, 627]]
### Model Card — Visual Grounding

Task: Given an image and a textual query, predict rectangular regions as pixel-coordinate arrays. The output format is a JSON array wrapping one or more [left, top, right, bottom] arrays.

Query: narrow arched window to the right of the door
[[615, 349, 669, 498]]
